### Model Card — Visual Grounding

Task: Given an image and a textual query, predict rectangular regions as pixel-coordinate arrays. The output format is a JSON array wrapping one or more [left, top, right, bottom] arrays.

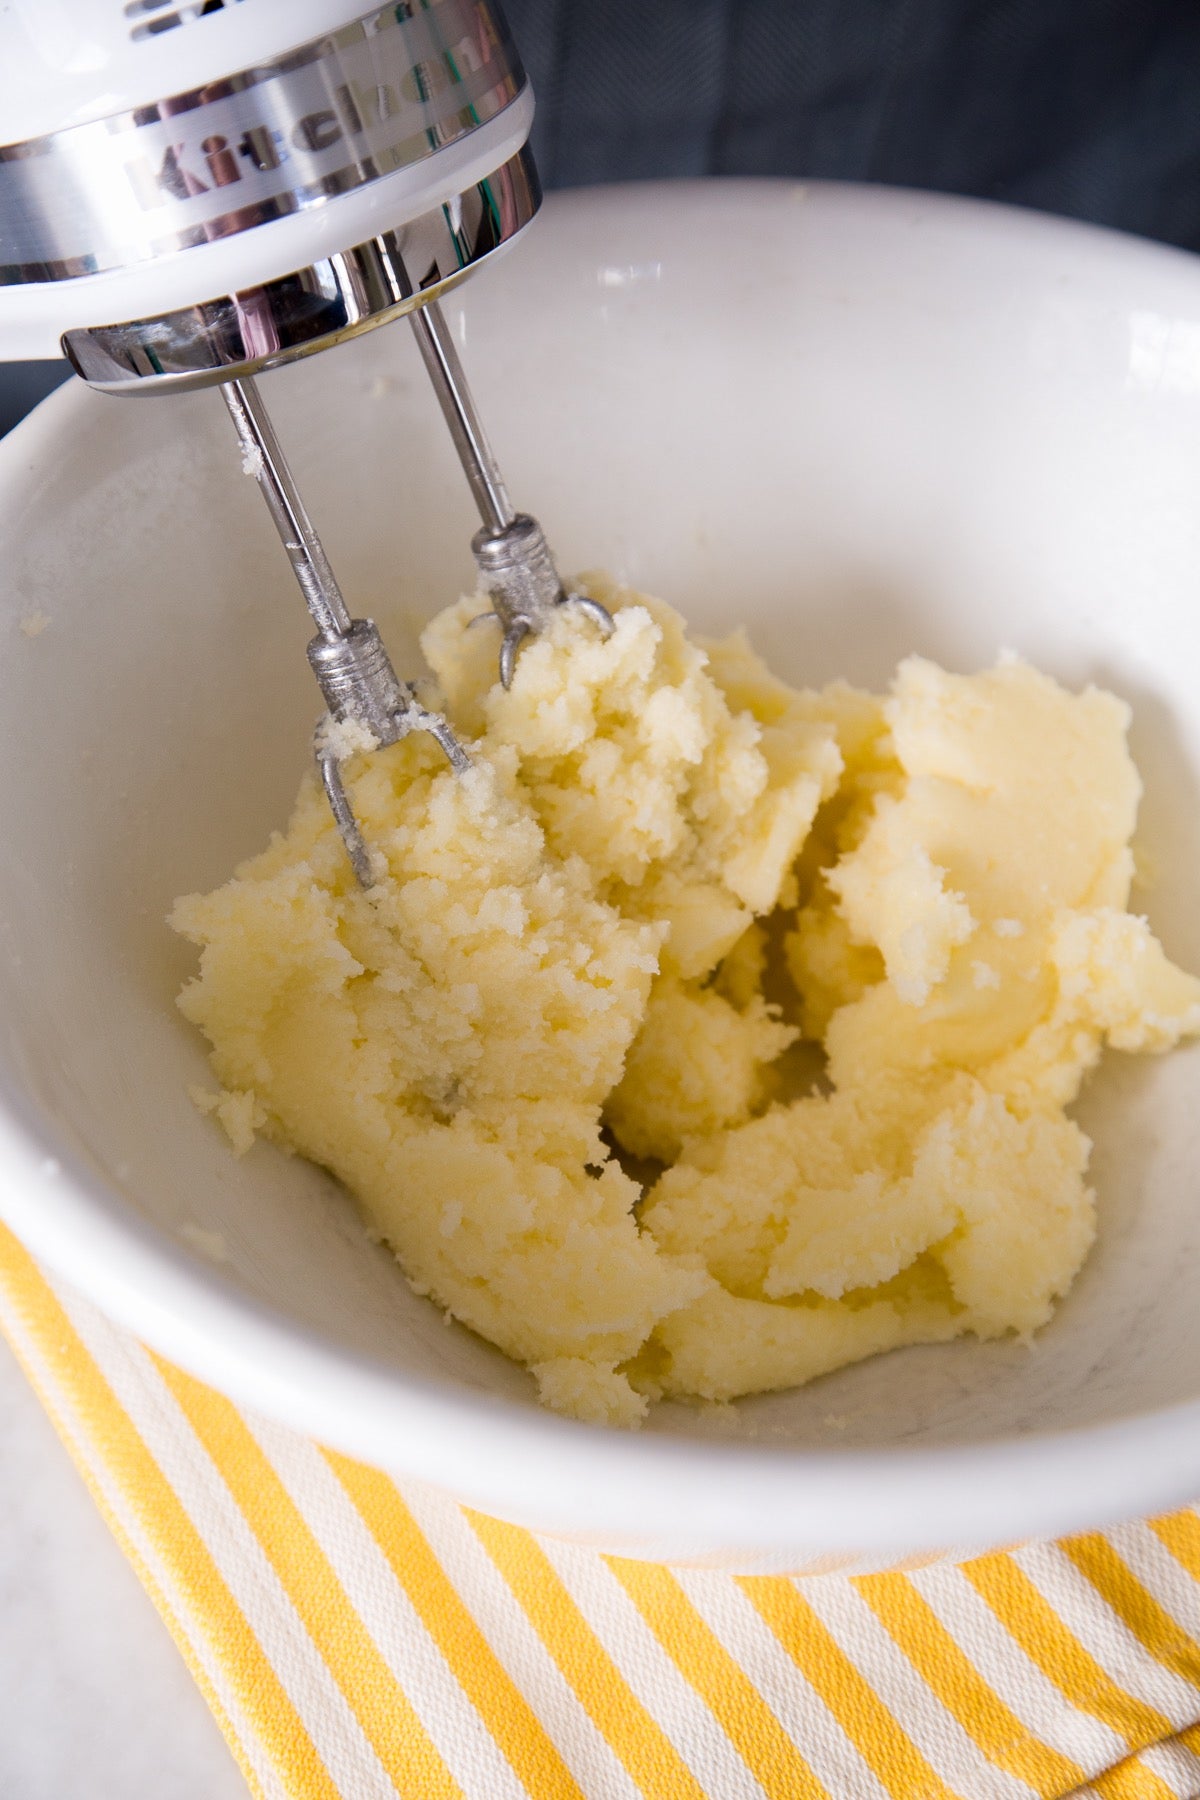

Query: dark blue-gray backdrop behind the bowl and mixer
[[0, 0, 1200, 430]]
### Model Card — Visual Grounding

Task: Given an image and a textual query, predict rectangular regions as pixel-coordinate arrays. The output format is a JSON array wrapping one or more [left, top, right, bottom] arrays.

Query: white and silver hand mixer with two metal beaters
[[0, 0, 612, 887]]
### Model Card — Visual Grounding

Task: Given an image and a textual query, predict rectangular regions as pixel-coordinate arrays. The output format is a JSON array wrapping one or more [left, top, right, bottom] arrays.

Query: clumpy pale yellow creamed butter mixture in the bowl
[[173, 578, 1200, 1426]]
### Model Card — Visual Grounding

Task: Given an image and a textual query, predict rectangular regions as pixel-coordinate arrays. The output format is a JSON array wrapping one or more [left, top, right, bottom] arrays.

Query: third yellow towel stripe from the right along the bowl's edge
[[963, 1555, 1171, 1750]]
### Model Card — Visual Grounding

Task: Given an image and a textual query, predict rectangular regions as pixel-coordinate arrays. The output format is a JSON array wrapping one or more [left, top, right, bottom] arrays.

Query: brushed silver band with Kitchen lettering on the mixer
[[0, 0, 525, 284]]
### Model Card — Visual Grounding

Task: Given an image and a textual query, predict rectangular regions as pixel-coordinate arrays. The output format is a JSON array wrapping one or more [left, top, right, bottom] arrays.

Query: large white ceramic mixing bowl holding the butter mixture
[[0, 182, 1200, 1571]]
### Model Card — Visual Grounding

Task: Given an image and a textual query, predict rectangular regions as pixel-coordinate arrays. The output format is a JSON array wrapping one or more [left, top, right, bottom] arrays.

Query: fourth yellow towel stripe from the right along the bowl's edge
[[855, 1575, 1085, 1800]]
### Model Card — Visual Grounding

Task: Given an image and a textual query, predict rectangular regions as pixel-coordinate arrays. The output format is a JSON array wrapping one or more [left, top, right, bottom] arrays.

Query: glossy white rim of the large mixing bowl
[[0, 178, 1200, 1561]]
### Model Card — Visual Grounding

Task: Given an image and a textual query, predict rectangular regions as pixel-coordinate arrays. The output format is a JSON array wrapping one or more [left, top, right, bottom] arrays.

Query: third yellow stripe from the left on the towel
[[324, 1451, 585, 1800]]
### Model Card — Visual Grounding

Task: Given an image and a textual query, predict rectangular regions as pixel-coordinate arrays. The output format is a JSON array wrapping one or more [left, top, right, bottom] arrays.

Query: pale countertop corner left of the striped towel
[[0, 1339, 248, 1800]]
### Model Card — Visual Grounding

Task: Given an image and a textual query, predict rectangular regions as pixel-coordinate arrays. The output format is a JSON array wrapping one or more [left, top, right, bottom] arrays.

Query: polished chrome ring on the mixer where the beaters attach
[[63, 149, 542, 394]]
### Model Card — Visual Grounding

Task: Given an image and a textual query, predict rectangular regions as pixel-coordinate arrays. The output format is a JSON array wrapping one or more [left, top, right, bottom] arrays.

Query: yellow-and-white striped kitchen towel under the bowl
[[0, 1231, 1200, 1800]]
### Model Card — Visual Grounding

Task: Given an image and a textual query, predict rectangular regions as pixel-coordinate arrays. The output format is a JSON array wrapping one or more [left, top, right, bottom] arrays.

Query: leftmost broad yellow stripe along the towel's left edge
[[0, 1226, 338, 1800]]
